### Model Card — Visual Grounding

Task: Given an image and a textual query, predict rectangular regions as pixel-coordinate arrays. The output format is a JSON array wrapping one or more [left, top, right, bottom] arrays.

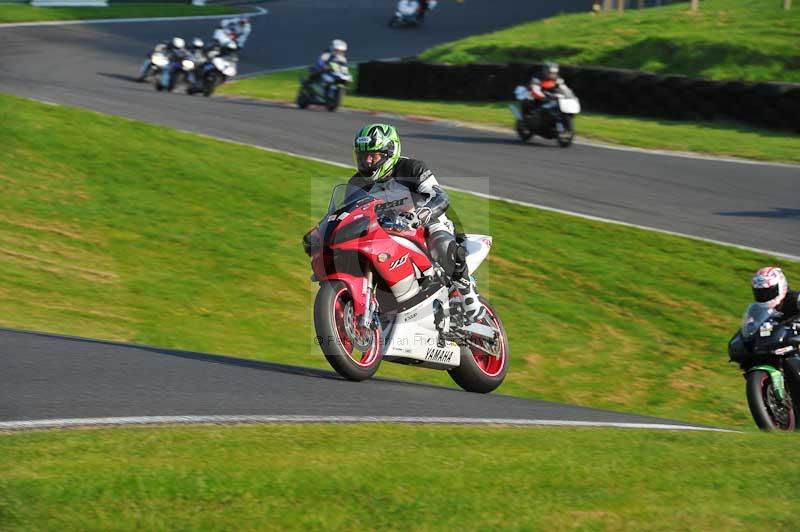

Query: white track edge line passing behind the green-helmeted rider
[[180, 129, 800, 262]]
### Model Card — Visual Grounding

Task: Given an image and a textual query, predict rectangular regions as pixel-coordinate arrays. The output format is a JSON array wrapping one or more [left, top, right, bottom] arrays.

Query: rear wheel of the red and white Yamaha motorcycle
[[448, 296, 509, 393]]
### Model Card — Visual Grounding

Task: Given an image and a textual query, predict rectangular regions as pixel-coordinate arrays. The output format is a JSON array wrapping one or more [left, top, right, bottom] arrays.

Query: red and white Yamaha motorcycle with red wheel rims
[[303, 185, 509, 393]]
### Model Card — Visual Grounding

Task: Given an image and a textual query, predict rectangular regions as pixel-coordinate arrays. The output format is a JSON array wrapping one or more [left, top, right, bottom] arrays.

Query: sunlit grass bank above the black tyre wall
[[421, 0, 800, 82]]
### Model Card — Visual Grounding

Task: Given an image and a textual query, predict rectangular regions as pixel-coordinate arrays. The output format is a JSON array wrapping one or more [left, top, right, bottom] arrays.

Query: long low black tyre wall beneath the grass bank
[[357, 61, 800, 132]]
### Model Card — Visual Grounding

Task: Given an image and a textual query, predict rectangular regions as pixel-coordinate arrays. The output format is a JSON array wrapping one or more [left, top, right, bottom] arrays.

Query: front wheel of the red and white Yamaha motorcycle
[[314, 281, 382, 381]]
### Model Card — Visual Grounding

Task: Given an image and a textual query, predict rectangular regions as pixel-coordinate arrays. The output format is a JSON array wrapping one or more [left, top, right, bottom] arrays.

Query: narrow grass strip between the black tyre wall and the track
[[220, 70, 800, 163]]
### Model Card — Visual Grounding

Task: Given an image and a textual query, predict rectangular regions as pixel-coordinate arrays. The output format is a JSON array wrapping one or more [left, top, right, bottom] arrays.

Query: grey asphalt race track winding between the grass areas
[[0, 0, 800, 424]]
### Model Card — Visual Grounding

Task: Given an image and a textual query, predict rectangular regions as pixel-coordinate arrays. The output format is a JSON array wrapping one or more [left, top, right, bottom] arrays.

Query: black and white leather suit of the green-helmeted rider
[[348, 157, 463, 279]]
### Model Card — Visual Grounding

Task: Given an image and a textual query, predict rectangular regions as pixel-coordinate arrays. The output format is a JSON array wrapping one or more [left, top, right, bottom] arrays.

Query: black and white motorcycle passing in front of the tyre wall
[[511, 87, 581, 148]]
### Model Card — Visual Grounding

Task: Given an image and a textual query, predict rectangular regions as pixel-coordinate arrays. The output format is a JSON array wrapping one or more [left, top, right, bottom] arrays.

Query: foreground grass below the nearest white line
[[0, 425, 800, 530]]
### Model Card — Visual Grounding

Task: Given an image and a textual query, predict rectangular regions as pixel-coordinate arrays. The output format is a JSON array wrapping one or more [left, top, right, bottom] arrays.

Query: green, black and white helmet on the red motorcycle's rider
[[353, 124, 400, 181]]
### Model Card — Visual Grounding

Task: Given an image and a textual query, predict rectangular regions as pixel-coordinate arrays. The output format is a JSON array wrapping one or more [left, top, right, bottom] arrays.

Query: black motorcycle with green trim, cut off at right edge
[[728, 303, 800, 431]]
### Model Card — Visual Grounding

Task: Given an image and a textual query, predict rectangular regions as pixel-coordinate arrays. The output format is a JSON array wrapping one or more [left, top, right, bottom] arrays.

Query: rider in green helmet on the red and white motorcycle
[[348, 124, 485, 323]]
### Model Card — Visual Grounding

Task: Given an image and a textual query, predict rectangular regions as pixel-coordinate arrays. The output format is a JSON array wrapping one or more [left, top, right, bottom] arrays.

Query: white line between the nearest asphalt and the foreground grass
[[0, 416, 736, 432]]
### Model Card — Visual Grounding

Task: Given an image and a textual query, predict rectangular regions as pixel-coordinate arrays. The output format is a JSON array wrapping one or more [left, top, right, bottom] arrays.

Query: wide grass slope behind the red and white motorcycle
[[0, 91, 800, 426]]
